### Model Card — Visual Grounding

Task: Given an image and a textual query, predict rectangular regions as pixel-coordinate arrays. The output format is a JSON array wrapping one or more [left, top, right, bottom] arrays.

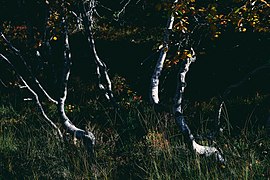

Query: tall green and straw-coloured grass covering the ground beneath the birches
[[0, 83, 270, 180]]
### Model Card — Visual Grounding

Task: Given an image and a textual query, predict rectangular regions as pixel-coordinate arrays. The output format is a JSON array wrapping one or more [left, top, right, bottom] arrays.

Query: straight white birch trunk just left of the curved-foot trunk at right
[[150, 0, 178, 104]]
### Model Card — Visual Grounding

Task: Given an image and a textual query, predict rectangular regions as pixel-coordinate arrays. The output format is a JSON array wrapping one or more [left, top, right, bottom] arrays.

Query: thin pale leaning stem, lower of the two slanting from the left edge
[[0, 54, 63, 139]]
